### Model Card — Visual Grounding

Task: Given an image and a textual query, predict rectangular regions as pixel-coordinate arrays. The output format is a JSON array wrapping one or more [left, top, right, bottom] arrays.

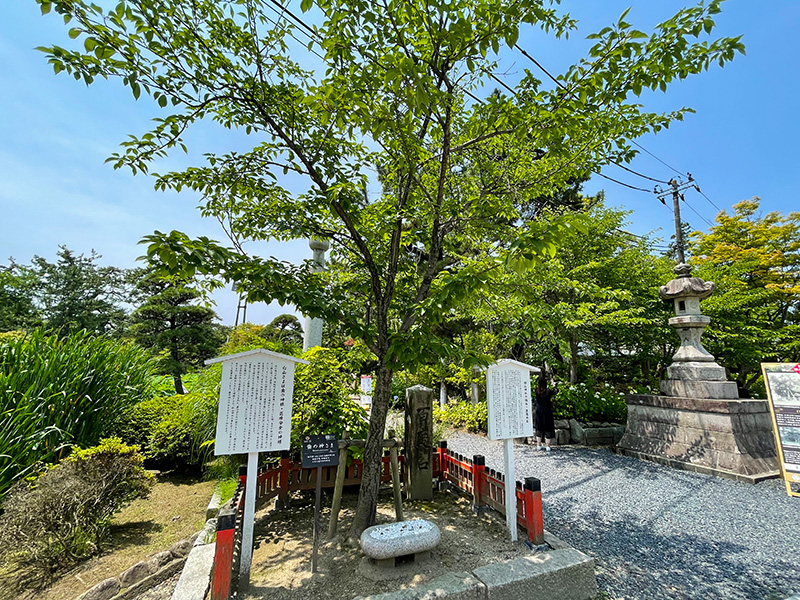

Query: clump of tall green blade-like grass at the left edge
[[0, 330, 153, 498]]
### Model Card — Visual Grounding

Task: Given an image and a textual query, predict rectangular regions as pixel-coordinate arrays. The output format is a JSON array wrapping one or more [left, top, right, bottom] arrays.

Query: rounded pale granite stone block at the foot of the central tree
[[361, 519, 442, 560]]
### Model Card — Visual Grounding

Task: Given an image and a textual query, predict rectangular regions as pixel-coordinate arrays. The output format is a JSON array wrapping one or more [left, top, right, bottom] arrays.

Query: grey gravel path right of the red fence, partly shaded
[[448, 433, 800, 600]]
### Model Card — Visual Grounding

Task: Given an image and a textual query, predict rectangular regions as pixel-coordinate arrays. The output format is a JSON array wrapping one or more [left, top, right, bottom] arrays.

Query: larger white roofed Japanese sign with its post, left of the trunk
[[206, 348, 308, 589]]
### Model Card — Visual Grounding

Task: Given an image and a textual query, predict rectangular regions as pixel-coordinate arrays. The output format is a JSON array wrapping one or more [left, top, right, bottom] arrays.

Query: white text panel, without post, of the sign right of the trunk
[[486, 359, 539, 440]]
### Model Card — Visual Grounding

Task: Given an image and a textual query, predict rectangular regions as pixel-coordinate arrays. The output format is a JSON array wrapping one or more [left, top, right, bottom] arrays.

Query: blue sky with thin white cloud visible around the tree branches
[[0, 0, 800, 323]]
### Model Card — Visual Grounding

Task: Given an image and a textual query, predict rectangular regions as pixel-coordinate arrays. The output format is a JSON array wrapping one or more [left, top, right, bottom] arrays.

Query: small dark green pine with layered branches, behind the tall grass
[[130, 271, 225, 394]]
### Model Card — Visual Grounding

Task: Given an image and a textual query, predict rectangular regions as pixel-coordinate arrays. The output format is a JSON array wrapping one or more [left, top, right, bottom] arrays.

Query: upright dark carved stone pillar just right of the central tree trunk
[[404, 385, 433, 500]]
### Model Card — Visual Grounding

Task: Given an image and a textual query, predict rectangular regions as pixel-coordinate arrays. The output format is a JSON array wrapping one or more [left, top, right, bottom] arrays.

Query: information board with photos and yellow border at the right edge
[[761, 363, 800, 497]]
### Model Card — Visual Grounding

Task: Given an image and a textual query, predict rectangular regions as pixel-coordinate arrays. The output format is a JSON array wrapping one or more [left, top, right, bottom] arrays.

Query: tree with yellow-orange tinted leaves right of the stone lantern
[[690, 198, 800, 397]]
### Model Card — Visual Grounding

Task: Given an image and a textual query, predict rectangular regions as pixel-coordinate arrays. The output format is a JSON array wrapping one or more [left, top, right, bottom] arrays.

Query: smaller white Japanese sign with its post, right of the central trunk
[[486, 359, 539, 542]]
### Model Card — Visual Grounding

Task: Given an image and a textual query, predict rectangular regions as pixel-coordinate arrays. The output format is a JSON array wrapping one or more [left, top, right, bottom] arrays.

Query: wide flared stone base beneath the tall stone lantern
[[617, 394, 778, 483]]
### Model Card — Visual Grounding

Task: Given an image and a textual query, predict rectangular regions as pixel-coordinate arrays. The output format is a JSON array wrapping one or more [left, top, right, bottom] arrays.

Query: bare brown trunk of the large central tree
[[348, 365, 392, 540]]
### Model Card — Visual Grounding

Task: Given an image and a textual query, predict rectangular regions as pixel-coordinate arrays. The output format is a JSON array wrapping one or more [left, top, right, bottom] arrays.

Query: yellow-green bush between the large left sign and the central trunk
[[292, 346, 367, 448]]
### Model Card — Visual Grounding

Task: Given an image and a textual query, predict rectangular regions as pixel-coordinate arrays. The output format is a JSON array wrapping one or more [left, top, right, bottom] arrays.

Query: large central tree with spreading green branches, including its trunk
[[37, 0, 742, 535]]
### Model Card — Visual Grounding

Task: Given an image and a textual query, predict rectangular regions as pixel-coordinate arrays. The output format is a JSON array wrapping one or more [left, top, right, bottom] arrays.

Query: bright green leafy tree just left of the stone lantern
[[473, 203, 673, 383]]
